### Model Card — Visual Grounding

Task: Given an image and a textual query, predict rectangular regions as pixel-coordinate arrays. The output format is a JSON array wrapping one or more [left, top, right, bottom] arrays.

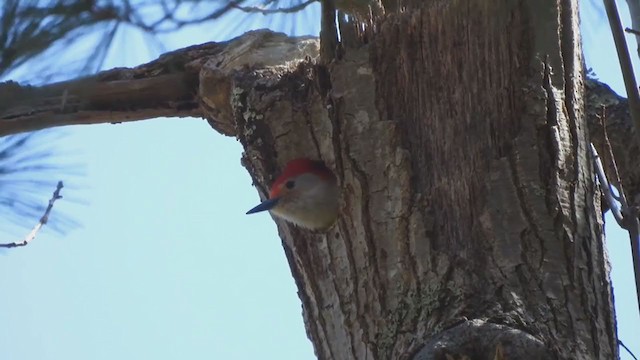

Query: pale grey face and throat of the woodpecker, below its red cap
[[271, 173, 338, 229]]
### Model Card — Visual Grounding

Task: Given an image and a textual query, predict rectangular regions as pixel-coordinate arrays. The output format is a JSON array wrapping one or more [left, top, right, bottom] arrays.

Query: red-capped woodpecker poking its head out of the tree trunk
[[247, 159, 339, 230]]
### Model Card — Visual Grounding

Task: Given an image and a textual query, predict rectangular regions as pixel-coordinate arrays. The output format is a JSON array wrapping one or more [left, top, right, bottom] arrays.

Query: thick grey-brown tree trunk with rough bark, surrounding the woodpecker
[[0, 0, 638, 359]]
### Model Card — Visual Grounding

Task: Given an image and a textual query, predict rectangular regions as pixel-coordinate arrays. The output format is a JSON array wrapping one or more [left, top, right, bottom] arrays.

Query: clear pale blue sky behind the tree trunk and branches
[[0, 2, 640, 360]]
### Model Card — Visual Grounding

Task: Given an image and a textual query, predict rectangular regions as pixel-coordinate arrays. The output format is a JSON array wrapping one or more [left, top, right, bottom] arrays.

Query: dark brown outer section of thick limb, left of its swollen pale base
[[0, 69, 201, 135]]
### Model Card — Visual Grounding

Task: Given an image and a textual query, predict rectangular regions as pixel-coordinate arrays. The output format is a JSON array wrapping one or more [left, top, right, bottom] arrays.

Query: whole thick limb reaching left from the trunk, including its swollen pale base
[[0, 30, 318, 136]]
